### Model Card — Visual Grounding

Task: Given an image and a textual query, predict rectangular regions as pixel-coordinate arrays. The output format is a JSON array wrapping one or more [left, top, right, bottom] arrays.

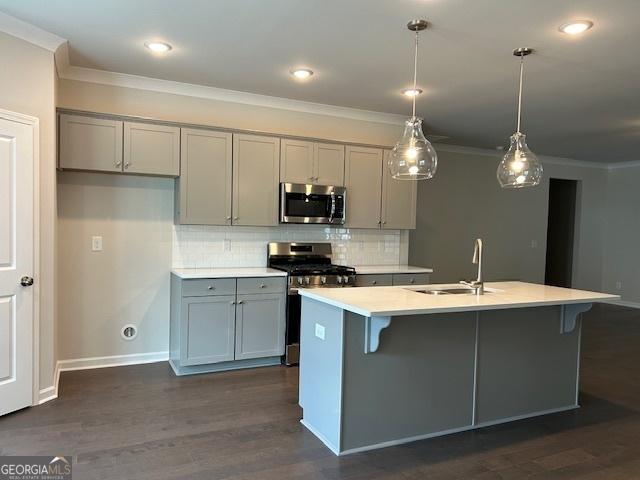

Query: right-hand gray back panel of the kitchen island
[[476, 306, 580, 424]]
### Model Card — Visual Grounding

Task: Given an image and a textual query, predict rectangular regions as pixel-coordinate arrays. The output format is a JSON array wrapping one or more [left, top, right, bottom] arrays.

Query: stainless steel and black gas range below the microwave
[[267, 242, 356, 365]]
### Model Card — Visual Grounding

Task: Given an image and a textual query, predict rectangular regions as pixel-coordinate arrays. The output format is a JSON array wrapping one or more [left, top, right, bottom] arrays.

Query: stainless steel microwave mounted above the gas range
[[280, 183, 347, 225]]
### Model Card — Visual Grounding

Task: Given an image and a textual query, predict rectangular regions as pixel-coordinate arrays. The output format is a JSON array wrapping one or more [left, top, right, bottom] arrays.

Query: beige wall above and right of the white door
[[0, 32, 56, 390]]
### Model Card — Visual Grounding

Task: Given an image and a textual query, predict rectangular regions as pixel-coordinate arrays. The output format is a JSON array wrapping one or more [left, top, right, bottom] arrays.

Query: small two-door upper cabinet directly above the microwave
[[280, 138, 344, 186]]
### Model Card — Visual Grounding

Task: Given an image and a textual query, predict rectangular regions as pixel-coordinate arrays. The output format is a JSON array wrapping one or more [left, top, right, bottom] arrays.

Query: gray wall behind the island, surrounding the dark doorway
[[409, 145, 607, 290]]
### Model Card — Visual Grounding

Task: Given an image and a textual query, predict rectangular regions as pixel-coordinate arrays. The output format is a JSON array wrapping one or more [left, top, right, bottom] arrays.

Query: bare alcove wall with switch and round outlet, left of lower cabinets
[[58, 172, 174, 360]]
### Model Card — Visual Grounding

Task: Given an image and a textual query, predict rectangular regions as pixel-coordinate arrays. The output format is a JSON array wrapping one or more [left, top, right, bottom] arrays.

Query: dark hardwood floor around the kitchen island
[[0, 307, 640, 480]]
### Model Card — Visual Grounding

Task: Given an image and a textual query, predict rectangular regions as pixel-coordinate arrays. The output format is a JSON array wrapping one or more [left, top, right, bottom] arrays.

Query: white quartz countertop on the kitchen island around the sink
[[298, 282, 620, 317]]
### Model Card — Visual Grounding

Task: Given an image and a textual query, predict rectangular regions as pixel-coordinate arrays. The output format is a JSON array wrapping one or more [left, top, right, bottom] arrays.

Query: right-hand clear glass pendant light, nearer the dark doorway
[[497, 47, 542, 188]]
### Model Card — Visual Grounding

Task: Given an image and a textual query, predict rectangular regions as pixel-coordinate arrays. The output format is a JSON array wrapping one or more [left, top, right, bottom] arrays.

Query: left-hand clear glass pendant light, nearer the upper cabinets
[[389, 20, 438, 180]]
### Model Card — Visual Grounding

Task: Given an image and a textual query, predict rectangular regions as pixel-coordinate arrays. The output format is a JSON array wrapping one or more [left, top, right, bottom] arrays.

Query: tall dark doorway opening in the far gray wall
[[544, 178, 578, 288]]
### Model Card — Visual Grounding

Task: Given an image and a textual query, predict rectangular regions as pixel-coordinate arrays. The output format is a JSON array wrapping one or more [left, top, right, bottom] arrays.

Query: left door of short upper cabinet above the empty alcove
[[59, 115, 122, 172]]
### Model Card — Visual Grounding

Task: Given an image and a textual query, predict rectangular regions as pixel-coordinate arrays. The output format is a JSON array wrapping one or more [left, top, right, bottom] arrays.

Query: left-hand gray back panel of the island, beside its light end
[[342, 312, 476, 451]]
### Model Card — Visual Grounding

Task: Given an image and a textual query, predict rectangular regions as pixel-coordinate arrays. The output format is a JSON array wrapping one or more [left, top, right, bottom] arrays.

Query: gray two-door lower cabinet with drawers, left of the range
[[169, 275, 286, 375]]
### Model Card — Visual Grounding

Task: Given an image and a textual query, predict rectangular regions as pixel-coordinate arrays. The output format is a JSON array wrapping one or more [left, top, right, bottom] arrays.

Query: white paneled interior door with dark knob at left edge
[[0, 112, 34, 415]]
